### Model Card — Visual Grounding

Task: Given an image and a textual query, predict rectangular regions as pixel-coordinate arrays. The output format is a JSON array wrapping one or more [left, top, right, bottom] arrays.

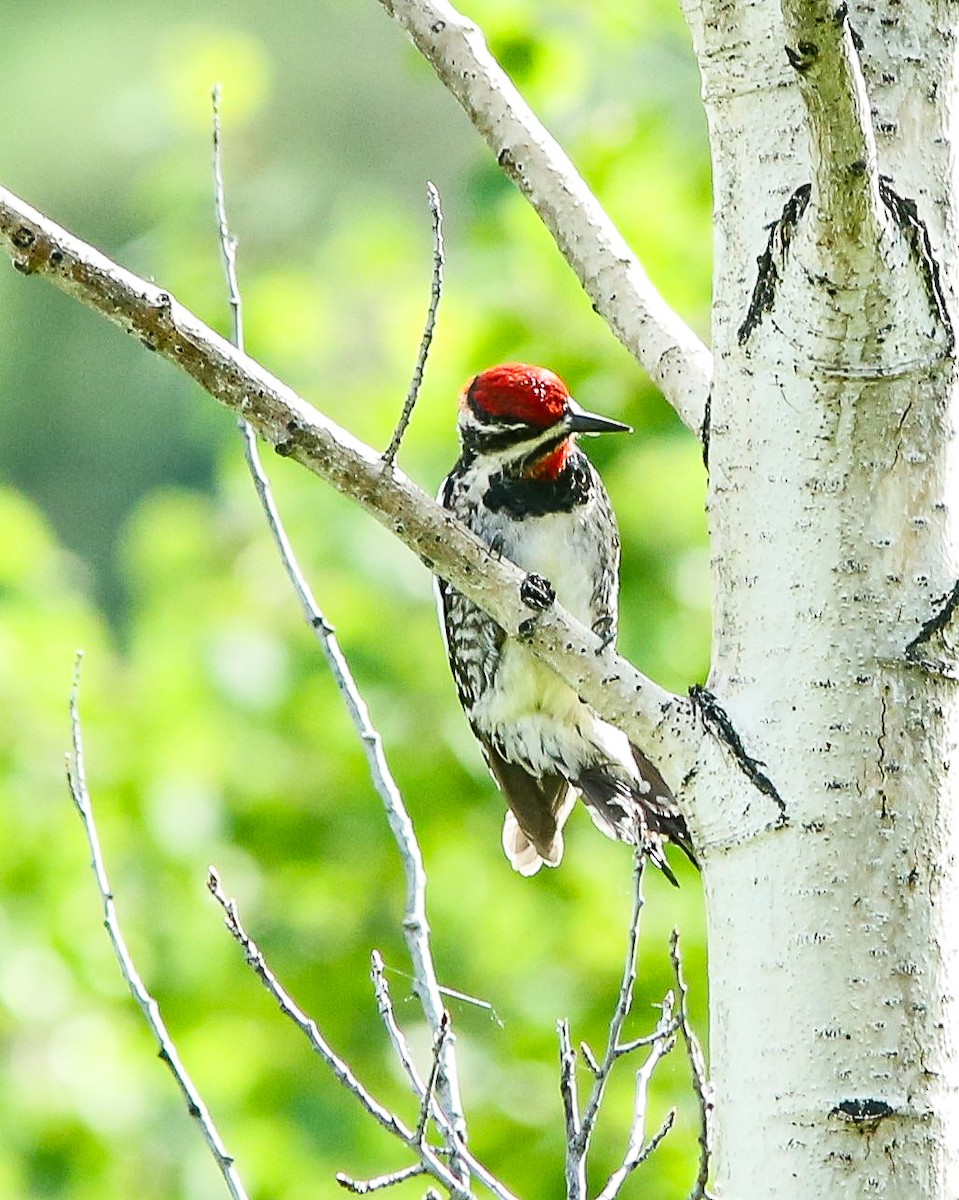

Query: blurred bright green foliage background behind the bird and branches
[[0, 0, 709, 1200]]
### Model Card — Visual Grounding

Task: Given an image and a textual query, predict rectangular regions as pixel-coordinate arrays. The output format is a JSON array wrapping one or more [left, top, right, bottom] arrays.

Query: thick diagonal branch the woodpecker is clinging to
[[0, 188, 703, 801]]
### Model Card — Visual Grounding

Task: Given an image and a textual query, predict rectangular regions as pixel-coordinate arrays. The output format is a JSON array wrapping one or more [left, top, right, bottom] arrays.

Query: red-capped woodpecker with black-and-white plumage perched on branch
[[437, 362, 695, 883]]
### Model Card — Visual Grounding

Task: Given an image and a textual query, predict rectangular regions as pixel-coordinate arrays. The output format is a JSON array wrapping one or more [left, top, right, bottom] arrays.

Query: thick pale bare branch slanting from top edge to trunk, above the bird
[[379, 0, 713, 436]]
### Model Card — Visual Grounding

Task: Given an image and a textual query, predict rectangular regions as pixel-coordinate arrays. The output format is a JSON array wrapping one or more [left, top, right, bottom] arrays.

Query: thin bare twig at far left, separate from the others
[[67, 653, 247, 1200]]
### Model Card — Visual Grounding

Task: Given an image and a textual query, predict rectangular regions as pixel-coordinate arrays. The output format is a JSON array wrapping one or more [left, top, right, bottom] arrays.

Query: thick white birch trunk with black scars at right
[[687, 0, 959, 1200]]
